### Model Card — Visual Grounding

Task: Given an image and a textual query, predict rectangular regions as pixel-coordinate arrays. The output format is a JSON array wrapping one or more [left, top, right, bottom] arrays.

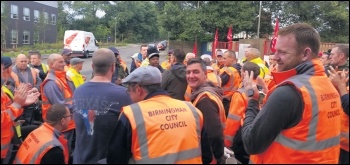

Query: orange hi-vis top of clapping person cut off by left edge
[[1, 89, 23, 159]]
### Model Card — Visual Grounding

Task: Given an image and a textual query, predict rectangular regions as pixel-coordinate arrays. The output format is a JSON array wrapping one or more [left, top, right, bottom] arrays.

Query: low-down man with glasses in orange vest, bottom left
[[13, 104, 73, 164]]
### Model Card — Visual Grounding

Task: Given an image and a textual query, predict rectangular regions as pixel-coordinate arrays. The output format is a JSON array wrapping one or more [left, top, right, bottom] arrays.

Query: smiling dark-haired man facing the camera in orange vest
[[186, 58, 232, 164]]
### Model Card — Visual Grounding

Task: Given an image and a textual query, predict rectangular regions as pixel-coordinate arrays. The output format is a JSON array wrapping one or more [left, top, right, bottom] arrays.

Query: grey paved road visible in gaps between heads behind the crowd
[[42, 44, 166, 81]]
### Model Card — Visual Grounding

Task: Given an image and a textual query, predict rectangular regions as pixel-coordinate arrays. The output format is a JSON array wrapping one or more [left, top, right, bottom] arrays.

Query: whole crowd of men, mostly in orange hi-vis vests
[[1, 23, 349, 164]]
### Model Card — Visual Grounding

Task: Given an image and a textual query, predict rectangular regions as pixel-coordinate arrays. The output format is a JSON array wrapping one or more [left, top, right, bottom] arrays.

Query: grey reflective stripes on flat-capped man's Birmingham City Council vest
[[130, 102, 202, 164]]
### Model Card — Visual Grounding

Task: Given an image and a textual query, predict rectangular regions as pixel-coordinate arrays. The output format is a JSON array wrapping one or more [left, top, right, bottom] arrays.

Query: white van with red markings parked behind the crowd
[[63, 30, 98, 58]]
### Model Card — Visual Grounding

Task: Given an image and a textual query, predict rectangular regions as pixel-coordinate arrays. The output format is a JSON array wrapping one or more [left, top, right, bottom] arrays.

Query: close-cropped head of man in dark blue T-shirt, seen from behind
[[92, 48, 115, 76]]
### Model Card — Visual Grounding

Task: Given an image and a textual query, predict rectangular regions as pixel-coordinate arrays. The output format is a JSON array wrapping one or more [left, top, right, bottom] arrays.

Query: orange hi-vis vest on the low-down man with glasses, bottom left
[[13, 123, 69, 164]]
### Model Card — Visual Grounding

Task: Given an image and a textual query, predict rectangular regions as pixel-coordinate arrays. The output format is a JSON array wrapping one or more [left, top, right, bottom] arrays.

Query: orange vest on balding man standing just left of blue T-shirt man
[[40, 70, 75, 132]]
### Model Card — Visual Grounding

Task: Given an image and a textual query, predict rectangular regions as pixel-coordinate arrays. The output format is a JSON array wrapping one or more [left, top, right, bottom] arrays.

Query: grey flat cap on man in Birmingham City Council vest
[[122, 66, 162, 85]]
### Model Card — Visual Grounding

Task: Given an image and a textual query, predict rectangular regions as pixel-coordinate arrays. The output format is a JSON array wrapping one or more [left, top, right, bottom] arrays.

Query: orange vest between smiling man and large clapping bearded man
[[224, 88, 248, 147]]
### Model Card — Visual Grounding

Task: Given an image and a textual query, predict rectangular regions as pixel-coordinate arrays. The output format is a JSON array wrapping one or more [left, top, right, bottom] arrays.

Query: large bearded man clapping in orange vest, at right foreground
[[242, 23, 342, 164]]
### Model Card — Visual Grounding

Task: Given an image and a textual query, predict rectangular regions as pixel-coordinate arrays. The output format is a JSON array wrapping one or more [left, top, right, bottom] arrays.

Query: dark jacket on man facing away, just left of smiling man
[[161, 63, 187, 100]]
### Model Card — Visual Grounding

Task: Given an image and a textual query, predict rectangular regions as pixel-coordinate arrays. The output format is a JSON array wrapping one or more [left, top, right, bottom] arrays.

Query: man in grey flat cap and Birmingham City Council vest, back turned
[[107, 66, 212, 164]]
